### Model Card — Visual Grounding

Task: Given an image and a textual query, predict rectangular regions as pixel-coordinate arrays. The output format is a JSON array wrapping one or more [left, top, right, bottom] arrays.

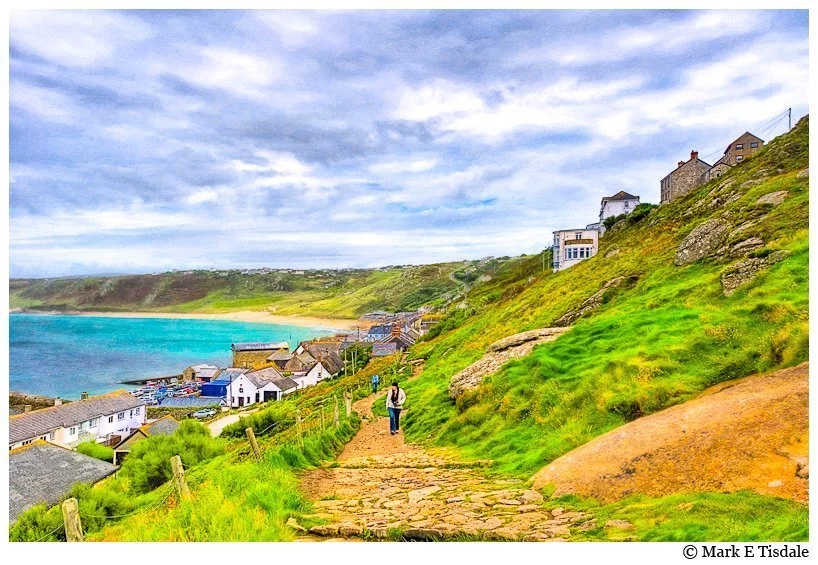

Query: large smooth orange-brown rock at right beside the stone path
[[533, 363, 809, 503]]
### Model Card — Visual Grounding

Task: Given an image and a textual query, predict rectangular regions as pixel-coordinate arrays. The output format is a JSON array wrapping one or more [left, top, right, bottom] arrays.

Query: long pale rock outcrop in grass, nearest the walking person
[[449, 328, 568, 399]]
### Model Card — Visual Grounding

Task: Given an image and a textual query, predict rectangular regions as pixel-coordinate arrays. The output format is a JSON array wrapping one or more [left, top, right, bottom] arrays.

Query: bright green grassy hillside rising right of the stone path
[[398, 117, 808, 476]]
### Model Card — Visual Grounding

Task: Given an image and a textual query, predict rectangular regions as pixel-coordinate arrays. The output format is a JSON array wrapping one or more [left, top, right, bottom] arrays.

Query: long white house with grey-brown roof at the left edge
[[9, 390, 147, 449]]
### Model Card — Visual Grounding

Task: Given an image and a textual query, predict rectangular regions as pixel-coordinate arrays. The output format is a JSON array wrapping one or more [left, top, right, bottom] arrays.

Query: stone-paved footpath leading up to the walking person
[[302, 386, 595, 541]]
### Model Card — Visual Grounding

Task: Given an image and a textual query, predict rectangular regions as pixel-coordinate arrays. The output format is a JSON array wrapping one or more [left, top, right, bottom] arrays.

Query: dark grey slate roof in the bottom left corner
[[9, 440, 119, 523]]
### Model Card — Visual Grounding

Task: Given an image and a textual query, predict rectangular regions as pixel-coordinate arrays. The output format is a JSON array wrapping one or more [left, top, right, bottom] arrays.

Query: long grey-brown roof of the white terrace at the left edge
[[9, 390, 145, 444]]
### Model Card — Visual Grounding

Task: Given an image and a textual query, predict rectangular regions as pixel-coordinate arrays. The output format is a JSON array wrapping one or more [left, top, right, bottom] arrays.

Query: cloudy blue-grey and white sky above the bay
[[10, 11, 808, 277]]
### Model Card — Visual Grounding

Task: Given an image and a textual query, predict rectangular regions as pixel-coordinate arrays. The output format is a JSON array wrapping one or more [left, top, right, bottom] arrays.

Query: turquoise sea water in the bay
[[9, 313, 332, 399]]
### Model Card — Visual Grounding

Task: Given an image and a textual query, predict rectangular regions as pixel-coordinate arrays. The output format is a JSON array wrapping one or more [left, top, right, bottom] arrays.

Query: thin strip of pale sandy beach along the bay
[[9, 308, 365, 332]]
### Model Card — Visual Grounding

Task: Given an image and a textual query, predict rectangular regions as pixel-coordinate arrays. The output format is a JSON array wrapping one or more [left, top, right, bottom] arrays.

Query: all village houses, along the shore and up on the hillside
[[9, 118, 796, 532]]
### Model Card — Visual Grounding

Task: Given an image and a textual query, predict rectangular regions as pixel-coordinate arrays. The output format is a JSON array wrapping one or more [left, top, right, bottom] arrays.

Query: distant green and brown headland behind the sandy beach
[[9, 259, 516, 318]]
